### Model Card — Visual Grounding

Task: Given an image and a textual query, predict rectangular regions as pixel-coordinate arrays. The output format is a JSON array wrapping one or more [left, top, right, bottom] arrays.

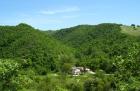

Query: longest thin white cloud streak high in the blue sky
[[40, 7, 80, 15]]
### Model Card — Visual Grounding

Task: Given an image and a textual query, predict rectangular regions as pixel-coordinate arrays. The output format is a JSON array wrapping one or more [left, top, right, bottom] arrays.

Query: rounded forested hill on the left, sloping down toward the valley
[[0, 23, 72, 74]]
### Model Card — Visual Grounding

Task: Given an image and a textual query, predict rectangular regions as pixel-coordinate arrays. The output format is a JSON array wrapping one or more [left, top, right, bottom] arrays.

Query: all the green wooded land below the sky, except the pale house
[[0, 23, 140, 91]]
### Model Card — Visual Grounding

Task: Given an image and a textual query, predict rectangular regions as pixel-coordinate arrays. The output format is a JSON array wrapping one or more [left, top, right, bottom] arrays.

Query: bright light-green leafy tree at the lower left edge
[[0, 59, 21, 91]]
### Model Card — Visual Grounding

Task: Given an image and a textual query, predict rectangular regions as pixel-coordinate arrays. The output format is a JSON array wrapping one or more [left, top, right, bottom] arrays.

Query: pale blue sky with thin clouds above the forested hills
[[0, 0, 140, 30]]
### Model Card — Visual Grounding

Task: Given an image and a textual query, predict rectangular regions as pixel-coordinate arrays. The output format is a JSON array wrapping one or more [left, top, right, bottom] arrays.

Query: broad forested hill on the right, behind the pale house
[[52, 23, 140, 74]]
